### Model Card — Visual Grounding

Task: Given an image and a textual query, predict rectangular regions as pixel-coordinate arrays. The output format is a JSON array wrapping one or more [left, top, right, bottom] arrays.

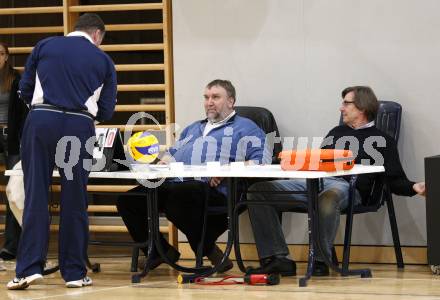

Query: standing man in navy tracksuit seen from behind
[[7, 14, 116, 289]]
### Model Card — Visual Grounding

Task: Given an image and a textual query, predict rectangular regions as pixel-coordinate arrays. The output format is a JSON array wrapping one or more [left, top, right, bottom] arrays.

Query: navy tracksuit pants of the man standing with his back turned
[[16, 109, 95, 281]]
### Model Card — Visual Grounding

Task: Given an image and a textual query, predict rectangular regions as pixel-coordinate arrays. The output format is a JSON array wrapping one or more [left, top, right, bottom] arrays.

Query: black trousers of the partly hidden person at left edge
[[0, 133, 21, 256]]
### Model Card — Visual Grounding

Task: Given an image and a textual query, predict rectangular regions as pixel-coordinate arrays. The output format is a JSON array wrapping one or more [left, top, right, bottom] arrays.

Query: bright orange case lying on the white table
[[279, 149, 354, 172]]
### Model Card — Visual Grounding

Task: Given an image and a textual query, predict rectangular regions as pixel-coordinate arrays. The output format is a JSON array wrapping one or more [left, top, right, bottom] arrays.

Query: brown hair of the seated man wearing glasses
[[342, 86, 379, 122]]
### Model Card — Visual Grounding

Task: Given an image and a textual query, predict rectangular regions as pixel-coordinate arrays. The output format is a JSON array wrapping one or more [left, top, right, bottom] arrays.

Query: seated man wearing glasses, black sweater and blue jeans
[[247, 86, 425, 276]]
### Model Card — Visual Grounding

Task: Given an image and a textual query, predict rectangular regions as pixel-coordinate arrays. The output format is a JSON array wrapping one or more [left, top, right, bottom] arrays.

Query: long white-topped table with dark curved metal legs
[[5, 163, 384, 286]]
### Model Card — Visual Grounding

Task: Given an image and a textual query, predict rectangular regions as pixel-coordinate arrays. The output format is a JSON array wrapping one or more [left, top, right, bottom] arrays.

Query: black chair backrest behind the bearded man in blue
[[235, 106, 282, 163]]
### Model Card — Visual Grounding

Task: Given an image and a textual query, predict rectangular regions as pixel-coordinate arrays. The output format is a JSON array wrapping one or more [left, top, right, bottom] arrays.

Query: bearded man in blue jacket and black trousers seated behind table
[[117, 80, 265, 272]]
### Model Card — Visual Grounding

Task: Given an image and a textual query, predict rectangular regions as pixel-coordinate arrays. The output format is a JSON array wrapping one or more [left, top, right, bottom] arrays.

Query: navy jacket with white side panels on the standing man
[[20, 31, 116, 121]]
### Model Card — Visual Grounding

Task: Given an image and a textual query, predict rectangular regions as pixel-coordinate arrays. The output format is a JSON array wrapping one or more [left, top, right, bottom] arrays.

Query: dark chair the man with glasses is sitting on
[[234, 101, 404, 276]]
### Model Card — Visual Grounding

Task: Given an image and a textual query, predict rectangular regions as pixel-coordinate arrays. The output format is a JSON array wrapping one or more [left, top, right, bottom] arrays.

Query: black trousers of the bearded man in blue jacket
[[117, 180, 227, 256]]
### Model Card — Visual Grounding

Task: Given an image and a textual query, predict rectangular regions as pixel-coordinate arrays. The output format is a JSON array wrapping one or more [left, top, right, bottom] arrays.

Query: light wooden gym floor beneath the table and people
[[0, 257, 440, 300]]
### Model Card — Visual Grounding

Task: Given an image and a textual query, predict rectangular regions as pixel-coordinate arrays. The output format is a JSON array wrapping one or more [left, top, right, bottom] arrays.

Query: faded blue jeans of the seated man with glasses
[[247, 177, 361, 261]]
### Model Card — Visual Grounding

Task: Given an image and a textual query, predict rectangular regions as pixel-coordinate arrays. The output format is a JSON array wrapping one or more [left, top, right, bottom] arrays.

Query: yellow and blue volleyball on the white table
[[127, 131, 159, 164]]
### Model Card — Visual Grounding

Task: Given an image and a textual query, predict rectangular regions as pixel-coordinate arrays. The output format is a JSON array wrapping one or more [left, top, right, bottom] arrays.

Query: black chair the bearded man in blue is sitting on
[[196, 106, 282, 267]]
